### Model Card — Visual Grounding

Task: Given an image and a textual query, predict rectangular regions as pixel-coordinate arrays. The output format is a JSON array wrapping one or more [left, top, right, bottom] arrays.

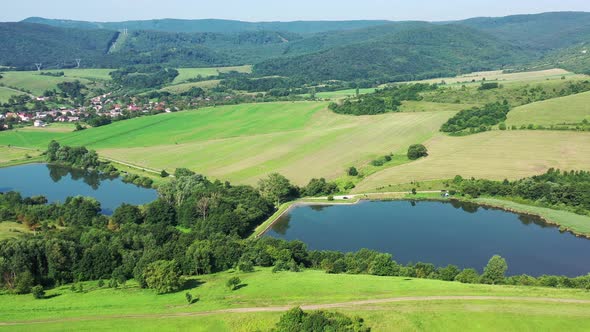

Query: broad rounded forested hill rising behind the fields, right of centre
[[254, 25, 534, 81]]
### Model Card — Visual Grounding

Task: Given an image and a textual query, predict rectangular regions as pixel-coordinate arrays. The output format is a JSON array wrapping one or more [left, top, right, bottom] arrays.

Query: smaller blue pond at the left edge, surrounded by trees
[[0, 164, 158, 215]]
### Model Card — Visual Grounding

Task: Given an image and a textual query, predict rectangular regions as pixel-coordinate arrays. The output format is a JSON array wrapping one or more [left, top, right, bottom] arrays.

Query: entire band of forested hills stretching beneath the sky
[[5, 13, 590, 80]]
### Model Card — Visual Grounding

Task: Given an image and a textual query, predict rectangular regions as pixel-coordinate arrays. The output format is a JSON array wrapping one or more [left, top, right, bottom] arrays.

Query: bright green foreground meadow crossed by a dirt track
[[0, 269, 590, 331]]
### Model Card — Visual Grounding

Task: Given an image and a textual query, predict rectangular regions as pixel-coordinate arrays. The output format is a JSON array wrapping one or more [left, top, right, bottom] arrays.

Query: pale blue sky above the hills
[[0, 0, 590, 22]]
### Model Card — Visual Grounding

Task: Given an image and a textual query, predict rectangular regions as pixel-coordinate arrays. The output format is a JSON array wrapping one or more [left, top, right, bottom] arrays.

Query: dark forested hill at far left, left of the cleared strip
[[0, 23, 118, 67]]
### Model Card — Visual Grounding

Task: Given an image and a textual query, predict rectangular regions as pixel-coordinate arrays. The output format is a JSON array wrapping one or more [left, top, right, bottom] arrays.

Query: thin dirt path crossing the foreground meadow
[[0, 296, 590, 327]]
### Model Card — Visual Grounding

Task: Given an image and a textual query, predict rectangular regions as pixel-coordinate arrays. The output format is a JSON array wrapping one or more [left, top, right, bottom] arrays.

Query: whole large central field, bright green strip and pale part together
[[0, 102, 454, 184]]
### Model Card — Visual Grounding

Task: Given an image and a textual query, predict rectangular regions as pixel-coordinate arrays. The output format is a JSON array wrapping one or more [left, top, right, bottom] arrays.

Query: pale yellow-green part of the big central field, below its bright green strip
[[98, 109, 454, 185]]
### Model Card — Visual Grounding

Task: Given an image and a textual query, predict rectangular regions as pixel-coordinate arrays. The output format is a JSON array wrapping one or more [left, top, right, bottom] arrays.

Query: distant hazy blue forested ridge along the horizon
[[23, 17, 391, 34]]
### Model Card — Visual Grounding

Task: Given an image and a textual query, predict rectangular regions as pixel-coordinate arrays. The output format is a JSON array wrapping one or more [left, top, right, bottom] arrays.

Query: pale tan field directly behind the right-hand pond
[[354, 130, 590, 192]]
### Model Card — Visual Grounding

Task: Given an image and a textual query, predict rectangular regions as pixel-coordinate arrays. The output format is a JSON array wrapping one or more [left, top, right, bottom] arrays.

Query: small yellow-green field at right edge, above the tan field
[[506, 92, 590, 126]]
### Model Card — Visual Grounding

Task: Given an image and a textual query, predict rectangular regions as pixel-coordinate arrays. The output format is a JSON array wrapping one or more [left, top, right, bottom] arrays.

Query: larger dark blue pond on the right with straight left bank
[[265, 201, 590, 276]]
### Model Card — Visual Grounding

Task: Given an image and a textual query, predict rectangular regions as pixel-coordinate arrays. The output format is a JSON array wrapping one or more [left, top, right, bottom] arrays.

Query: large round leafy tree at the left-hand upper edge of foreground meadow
[[144, 260, 182, 294]]
